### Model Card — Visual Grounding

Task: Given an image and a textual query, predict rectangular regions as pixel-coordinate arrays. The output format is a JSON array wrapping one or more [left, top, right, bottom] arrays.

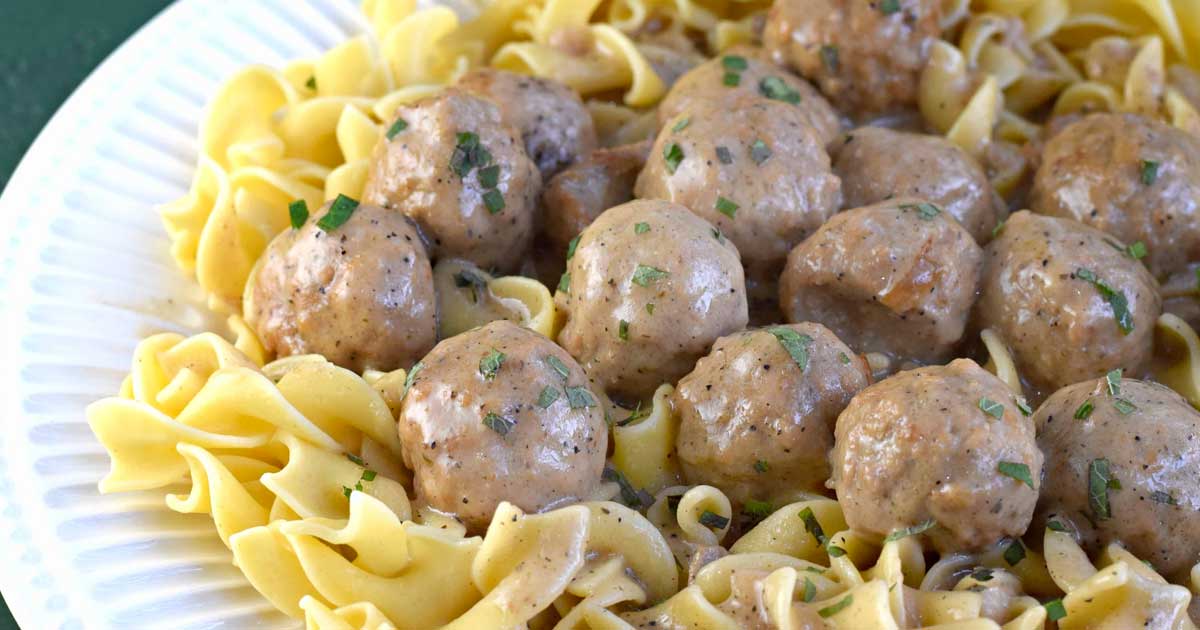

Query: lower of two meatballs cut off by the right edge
[[1033, 378, 1200, 583]]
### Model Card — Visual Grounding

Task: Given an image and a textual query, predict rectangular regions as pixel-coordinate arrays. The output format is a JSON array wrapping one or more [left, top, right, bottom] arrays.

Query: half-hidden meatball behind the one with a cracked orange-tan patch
[[830, 127, 1004, 242]]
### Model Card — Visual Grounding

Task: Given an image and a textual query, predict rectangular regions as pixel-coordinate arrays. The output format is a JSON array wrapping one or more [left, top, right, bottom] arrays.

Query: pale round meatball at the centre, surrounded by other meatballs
[[558, 200, 748, 402]]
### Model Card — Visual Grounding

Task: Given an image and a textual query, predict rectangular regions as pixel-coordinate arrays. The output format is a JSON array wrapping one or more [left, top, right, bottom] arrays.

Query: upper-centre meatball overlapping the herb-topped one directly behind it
[[635, 96, 841, 282]]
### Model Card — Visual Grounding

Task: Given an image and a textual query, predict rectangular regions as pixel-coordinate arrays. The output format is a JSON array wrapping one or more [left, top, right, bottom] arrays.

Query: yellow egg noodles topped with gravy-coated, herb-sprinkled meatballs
[[79, 0, 1200, 630]]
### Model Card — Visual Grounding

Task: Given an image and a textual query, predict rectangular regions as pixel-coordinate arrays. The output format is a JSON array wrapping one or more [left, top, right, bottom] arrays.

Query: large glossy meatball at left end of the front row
[[400, 320, 608, 533]]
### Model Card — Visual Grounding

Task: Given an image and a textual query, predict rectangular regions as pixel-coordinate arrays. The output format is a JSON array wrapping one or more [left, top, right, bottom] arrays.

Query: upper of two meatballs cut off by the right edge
[[1030, 114, 1200, 277]]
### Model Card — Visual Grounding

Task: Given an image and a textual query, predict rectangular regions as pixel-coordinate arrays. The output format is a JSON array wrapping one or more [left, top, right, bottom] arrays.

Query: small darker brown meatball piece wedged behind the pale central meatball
[[541, 140, 650, 251]]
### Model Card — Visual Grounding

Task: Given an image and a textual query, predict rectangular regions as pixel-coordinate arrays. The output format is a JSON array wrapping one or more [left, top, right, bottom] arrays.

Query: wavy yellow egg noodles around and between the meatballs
[[88, 0, 1200, 630]]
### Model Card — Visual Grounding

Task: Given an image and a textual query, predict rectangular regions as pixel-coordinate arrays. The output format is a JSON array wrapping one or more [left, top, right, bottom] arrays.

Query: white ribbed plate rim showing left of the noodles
[[0, 0, 366, 630]]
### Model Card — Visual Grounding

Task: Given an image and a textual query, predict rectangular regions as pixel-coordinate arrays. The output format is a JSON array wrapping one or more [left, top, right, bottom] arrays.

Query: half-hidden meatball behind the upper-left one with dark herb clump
[[458, 68, 596, 180]]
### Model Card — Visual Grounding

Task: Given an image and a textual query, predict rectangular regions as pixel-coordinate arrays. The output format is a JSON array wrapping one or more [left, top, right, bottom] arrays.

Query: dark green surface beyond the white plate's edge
[[0, 0, 170, 630]]
